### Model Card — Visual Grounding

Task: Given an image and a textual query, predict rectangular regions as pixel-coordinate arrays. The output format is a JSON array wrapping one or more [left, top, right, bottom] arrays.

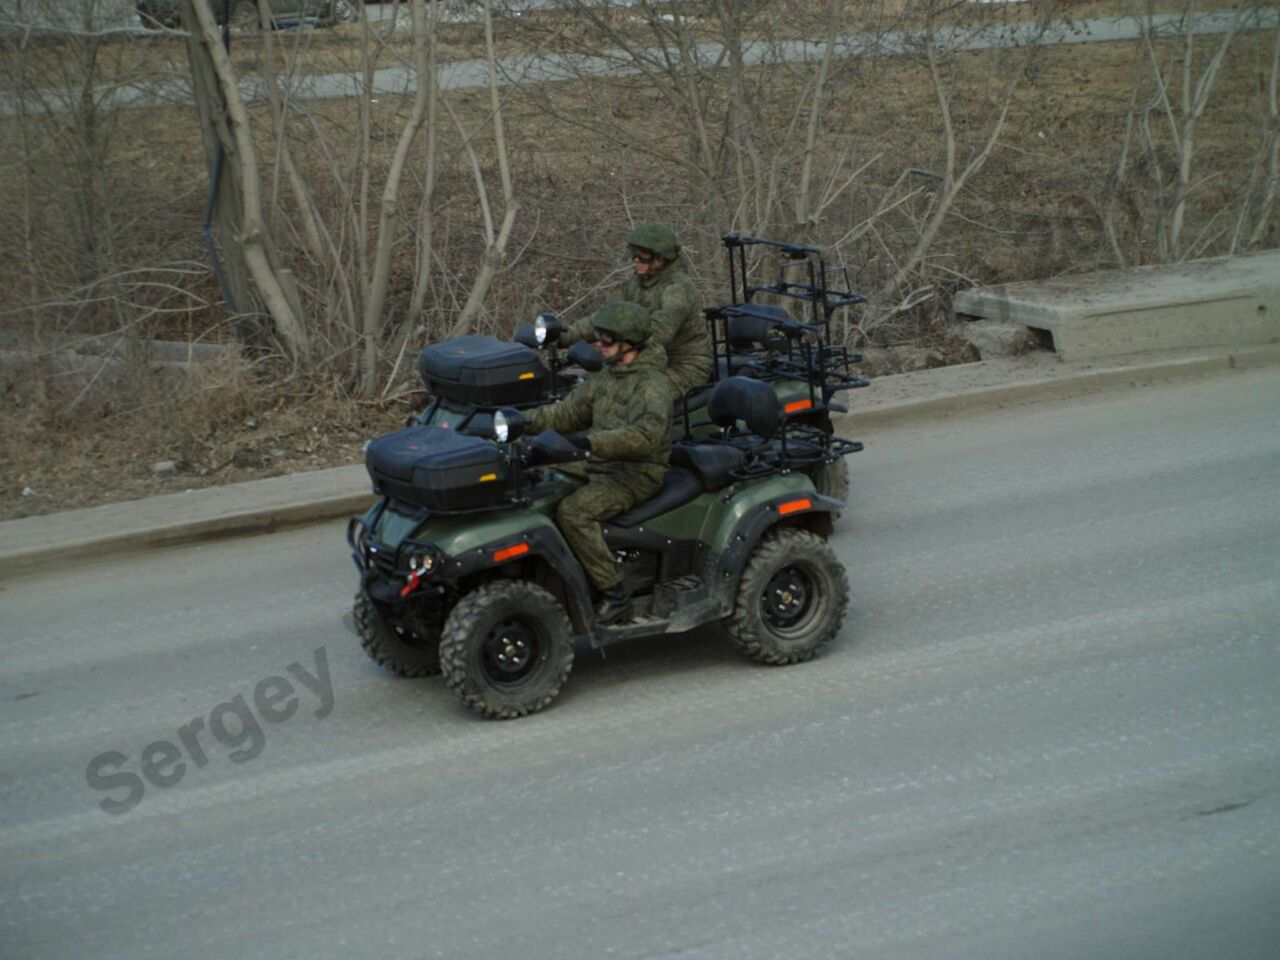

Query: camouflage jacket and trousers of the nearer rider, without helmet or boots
[[530, 342, 671, 591]]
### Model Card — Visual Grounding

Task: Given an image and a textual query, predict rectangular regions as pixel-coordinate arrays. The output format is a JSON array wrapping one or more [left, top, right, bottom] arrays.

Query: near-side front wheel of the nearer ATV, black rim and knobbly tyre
[[440, 580, 573, 719]]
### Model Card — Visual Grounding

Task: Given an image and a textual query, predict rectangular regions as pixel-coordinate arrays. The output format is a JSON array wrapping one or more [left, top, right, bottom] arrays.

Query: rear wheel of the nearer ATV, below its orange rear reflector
[[723, 527, 849, 664]]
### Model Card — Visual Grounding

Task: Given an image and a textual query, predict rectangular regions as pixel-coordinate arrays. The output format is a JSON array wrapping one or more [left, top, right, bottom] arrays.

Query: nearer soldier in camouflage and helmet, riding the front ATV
[[529, 301, 671, 623]]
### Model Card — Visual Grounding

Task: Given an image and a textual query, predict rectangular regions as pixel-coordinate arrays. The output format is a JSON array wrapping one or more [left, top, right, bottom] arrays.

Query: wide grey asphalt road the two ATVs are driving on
[[0, 370, 1280, 960]]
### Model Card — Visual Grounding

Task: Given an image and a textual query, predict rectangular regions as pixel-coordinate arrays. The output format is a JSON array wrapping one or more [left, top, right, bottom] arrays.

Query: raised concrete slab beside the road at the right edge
[[955, 250, 1280, 361]]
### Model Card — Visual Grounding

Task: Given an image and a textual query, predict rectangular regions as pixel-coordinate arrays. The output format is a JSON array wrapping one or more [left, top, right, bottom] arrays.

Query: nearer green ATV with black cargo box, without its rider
[[347, 376, 861, 718]]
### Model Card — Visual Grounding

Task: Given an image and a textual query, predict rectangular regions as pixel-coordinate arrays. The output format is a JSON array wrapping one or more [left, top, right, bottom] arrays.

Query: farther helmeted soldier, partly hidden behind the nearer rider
[[561, 223, 712, 401]]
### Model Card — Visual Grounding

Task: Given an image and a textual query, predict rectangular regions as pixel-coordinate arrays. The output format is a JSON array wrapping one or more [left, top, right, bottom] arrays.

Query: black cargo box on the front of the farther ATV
[[417, 335, 548, 407]]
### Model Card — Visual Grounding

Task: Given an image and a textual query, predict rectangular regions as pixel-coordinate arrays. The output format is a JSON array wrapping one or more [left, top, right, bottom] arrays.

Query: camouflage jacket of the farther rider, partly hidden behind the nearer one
[[562, 259, 712, 390]]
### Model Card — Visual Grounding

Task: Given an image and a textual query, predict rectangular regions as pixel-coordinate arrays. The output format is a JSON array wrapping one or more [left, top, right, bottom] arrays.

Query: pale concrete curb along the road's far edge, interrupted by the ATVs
[[0, 347, 1280, 580]]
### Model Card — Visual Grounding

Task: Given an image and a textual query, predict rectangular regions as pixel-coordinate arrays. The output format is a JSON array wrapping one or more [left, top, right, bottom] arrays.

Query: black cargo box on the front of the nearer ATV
[[365, 426, 511, 512]]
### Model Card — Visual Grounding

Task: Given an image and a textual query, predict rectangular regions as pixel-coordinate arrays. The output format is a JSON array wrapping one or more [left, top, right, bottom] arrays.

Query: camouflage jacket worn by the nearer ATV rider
[[529, 343, 671, 483]]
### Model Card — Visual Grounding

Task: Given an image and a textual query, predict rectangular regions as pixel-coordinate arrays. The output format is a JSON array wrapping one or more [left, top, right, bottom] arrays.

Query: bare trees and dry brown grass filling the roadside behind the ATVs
[[0, 0, 1280, 516]]
